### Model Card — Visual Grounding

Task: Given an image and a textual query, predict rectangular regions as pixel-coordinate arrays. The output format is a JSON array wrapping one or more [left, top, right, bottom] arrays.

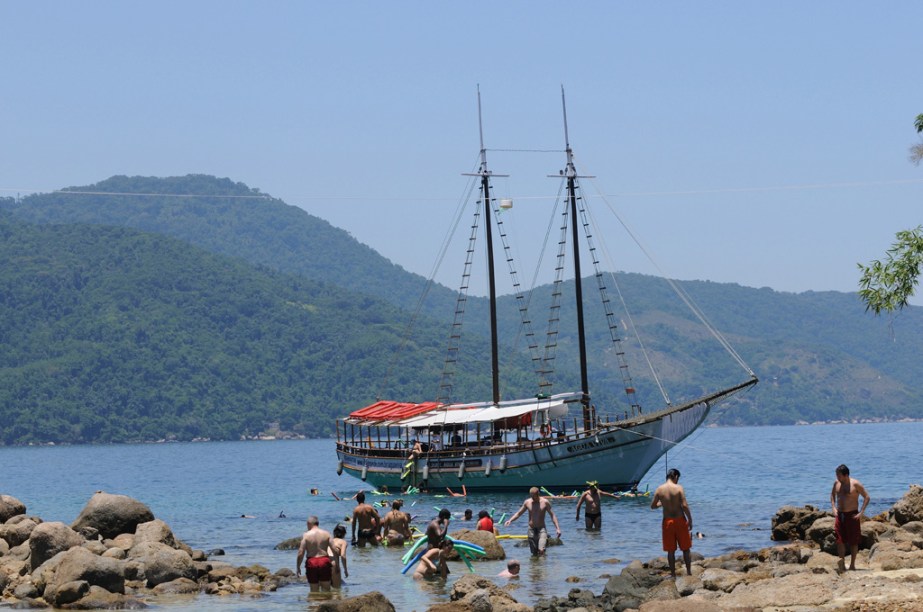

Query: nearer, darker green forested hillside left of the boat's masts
[[0, 213, 534, 444]]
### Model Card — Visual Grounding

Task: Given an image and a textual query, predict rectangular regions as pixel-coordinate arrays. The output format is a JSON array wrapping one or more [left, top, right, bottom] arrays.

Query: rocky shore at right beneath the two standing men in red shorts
[[534, 491, 923, 612]]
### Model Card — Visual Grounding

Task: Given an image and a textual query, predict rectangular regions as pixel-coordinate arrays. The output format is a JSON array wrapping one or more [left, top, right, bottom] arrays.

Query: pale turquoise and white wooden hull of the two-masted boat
[[337, 402, 710, 491]]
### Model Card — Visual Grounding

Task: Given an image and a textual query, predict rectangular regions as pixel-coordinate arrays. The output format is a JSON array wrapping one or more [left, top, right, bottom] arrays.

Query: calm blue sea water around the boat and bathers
[[0, 423, 923, 611]]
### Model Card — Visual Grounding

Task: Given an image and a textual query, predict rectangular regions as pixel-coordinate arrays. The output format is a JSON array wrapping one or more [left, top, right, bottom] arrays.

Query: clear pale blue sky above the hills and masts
[[0, 0, 923, 304]]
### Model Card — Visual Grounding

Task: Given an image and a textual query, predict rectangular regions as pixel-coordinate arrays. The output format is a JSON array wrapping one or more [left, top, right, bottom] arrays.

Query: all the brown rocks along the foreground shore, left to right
[[0, 485, 923, 612]]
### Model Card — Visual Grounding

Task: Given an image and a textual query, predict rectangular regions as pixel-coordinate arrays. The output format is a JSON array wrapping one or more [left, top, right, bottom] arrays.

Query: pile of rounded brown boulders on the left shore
[[0, 492, 295, 610]]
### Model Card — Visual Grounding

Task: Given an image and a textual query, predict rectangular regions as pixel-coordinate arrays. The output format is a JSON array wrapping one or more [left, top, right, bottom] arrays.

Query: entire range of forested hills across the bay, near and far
[[0, 175, 923, 444]]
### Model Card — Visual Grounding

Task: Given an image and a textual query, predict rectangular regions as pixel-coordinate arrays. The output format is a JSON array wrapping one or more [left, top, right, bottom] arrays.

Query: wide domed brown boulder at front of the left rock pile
[[32, 546, 125, 601]]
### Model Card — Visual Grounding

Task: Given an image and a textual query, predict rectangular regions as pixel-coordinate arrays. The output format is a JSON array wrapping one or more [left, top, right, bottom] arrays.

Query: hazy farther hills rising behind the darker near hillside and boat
[[0, 175, 923, 436]]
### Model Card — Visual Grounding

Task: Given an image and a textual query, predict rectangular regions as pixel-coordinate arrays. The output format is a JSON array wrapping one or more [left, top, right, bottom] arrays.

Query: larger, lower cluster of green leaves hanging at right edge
[[858, 226, 923, 315]]
